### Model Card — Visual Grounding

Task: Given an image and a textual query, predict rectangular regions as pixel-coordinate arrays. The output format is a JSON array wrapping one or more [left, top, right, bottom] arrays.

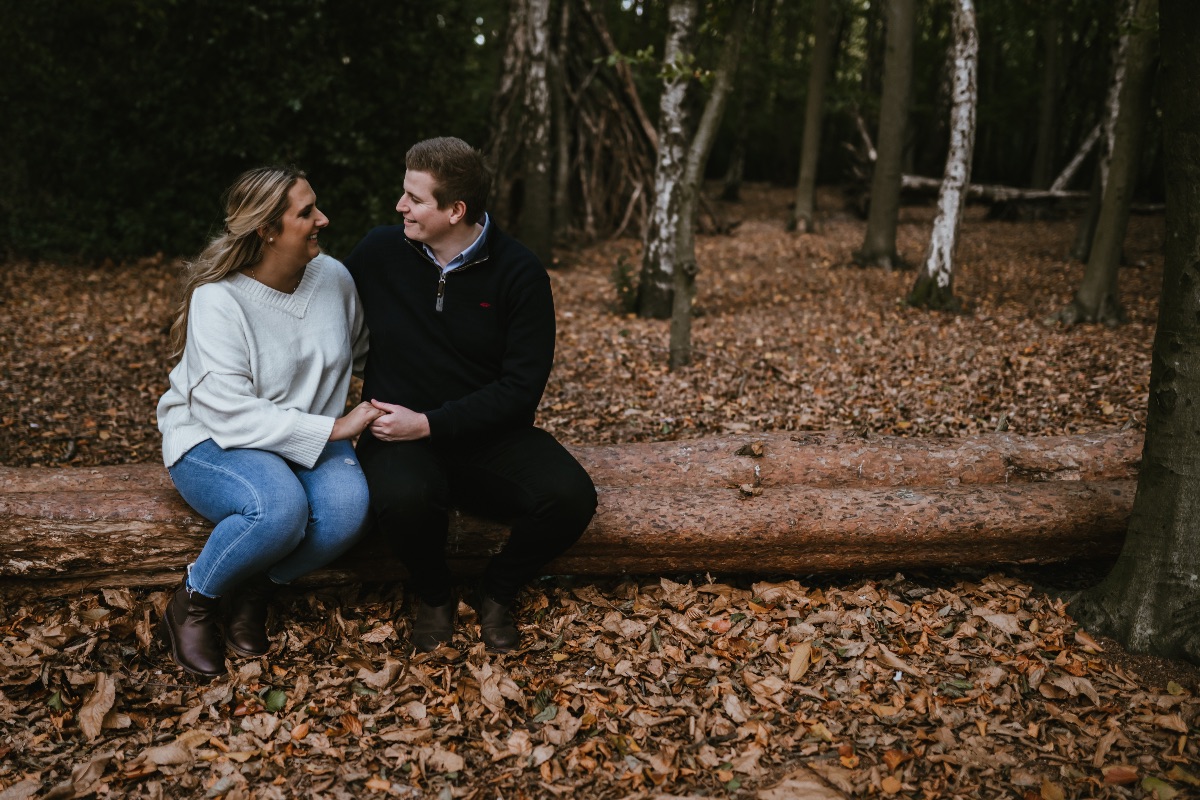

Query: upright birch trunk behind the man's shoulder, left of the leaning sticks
[[521, 0, 554, 263]]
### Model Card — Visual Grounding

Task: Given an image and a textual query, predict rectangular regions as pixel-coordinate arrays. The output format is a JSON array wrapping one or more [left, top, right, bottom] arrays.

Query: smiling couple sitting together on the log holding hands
[[158, 138, 596, 676]]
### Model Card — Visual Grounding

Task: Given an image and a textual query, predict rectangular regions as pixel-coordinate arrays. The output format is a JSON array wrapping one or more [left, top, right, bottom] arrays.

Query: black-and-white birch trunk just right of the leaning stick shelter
[[637, 0, 698, 319]]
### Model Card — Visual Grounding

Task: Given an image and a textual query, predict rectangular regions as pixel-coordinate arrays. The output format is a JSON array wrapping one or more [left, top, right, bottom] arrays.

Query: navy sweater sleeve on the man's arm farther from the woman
[[425, 270, 554, 441]]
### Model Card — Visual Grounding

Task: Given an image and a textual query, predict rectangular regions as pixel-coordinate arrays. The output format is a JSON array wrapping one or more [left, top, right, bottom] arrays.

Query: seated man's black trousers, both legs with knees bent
[[358, 427, 596, 606]]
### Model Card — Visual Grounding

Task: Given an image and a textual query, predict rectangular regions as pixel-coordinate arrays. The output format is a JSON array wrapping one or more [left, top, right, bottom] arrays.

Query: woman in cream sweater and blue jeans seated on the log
[[158, 167, 380, 676]]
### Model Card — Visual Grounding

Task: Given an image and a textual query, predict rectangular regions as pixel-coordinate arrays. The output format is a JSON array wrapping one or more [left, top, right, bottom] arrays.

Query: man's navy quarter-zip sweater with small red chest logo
[[346, 221, 554, 444]]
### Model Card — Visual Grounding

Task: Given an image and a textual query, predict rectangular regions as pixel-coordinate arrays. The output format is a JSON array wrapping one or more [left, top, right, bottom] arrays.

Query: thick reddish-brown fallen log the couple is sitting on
[[0, 432, 1141, 591]]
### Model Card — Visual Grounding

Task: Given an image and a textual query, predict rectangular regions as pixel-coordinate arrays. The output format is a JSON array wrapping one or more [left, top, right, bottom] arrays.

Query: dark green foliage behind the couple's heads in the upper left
[[0, 0, 500, 260]]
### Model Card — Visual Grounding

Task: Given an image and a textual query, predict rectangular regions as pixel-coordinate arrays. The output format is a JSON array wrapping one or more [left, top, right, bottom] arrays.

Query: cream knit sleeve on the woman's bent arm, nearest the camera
[[186, 291, 334, 468]]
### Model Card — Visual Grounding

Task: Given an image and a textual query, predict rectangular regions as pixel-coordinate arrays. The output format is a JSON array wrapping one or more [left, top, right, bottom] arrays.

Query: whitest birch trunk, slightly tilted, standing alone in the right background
[[908, 0, 979, 311]]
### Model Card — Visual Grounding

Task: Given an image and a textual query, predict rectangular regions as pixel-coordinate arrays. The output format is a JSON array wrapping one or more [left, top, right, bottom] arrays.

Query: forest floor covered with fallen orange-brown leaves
[[0, 186, 1200, 800]]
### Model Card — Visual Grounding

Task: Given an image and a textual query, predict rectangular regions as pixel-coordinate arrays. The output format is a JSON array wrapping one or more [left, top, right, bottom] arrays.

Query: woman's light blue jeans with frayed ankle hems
[[169, 439, 367, 597]]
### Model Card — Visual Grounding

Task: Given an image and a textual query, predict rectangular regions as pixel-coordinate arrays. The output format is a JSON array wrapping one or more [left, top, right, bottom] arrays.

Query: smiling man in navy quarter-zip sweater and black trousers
[[346, 138, 596, 652]]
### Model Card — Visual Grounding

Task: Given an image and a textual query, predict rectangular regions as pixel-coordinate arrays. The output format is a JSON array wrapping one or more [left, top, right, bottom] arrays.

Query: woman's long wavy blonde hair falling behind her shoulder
[[170, 167, 306, 359]]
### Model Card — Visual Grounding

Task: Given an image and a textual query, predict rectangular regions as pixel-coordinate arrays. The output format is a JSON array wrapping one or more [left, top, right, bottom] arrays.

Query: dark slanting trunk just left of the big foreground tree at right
[[1060, 0, 1158, 325]]
